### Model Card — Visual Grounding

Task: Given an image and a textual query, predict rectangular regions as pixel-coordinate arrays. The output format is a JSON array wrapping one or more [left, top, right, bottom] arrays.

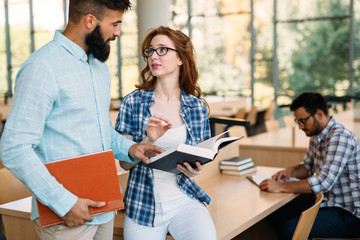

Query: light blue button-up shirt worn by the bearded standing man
[[0, 31, 134, 224]]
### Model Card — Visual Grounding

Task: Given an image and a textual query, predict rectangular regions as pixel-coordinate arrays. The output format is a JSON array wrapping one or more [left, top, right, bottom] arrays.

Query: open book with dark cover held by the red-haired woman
[[146, 131, 244, 174]]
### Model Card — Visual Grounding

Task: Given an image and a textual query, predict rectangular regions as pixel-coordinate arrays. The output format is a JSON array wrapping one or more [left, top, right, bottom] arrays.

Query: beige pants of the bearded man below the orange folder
[[35, 218, 114, 240]]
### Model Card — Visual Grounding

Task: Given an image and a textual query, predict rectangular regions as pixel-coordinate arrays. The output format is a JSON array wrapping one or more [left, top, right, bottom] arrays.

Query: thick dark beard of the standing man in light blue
[[85, 25, 114, 62]]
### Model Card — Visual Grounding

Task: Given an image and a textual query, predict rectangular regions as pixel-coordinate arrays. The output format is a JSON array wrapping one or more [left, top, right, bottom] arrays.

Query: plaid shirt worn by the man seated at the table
[[304, 117, 360, 218]]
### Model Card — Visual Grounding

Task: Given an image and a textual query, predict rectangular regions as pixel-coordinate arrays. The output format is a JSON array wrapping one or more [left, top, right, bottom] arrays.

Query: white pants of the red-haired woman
[[124, 196, 216, 240]]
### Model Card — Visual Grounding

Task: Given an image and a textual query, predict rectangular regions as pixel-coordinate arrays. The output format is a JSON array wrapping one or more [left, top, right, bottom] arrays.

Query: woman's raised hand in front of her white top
[[146, 114, 172, 143]]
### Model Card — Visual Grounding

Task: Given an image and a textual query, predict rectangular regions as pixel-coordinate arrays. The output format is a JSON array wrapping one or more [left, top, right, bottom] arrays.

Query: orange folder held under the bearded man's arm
[[37, 150, 124, 227]]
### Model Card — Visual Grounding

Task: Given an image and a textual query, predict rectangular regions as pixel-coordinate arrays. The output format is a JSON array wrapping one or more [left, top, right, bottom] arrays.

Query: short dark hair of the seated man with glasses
[[290, 92, 328, 116]]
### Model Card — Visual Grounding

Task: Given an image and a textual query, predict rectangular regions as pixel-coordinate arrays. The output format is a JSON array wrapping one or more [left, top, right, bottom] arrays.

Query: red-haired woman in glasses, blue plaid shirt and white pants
[[115, 26, 216, 240]]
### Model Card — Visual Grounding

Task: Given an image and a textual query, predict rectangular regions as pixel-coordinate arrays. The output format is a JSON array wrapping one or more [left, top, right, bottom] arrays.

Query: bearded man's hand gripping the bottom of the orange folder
[[62, 198, 105, 227]]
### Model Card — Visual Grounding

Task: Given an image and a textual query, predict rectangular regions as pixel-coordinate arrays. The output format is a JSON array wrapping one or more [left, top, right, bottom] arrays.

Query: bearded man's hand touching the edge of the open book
[[129, 143, 165, 163]]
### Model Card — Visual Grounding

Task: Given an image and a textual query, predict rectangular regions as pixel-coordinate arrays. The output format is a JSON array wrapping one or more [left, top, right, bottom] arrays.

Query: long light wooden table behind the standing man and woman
[[0, 150, 297, 240]]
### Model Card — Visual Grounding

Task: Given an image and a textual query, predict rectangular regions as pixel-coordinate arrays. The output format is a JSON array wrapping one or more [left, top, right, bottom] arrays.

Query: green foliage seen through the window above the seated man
[[280, 0, 360, 96]]
